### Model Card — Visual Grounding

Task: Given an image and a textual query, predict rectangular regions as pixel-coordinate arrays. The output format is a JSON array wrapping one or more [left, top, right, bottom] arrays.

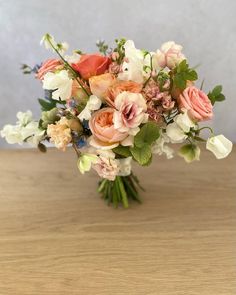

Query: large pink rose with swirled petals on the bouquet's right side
[[178, 86, 213, 121]]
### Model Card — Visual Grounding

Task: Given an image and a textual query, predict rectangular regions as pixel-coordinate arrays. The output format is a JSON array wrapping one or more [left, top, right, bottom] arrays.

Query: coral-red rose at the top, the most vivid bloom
[[71, 54, 111, 80]]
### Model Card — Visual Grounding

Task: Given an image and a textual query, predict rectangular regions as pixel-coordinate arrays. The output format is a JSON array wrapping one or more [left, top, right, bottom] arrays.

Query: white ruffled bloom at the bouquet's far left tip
[[0, 125, 24, 144]]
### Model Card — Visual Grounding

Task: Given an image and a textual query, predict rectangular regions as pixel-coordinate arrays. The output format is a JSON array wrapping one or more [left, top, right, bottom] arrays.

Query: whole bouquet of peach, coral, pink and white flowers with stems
[[1, 34, 232, 208]]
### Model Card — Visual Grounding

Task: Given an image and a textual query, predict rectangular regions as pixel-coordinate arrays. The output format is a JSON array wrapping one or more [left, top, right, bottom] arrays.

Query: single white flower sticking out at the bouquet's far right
[[206, 134, 233, 159]]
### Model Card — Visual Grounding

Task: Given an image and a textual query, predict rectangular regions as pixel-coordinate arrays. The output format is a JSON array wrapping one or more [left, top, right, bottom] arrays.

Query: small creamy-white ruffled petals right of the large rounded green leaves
[[152, 131, 174, 159]]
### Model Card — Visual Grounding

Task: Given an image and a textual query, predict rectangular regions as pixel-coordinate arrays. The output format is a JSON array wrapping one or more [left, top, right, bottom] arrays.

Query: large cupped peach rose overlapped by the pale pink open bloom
[[89, 108, 128, 149]]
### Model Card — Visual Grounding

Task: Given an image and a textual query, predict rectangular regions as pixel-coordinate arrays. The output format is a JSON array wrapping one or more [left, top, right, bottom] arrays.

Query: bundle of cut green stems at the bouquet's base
[[98, 174, 142, 208]]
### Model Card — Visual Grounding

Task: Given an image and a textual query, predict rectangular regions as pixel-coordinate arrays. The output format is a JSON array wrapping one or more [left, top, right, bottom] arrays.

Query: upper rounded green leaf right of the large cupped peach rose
[[134, 122, 160, 148]]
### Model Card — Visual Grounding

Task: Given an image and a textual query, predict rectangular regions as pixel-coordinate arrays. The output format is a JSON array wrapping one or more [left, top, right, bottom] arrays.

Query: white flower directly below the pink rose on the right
[[166, 111, 196, 143]]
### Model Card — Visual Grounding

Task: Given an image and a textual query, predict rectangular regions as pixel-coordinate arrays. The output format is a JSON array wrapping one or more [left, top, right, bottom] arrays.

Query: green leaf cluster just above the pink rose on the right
[[173, 59, 198, 90]]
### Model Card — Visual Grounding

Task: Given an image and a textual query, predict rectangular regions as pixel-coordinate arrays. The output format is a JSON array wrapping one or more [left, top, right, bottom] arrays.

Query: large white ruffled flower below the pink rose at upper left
[[43, 70, 73, 100]]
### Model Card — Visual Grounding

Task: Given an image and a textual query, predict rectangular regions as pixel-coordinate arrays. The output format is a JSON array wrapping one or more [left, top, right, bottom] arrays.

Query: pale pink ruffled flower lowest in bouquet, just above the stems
[[92, 156, 120, 181]]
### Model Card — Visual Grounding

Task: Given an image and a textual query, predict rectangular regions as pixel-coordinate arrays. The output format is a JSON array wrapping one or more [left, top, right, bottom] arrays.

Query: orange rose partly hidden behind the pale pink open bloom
[[105, 80, 143, 107]]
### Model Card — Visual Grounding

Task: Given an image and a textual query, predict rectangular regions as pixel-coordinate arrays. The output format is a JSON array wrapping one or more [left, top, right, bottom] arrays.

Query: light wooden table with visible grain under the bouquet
[[0, 149, 236, 295]]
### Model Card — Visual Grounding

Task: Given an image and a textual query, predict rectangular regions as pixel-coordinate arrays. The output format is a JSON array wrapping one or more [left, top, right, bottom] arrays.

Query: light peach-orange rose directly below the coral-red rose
[[89, 73, 116, 99]]
